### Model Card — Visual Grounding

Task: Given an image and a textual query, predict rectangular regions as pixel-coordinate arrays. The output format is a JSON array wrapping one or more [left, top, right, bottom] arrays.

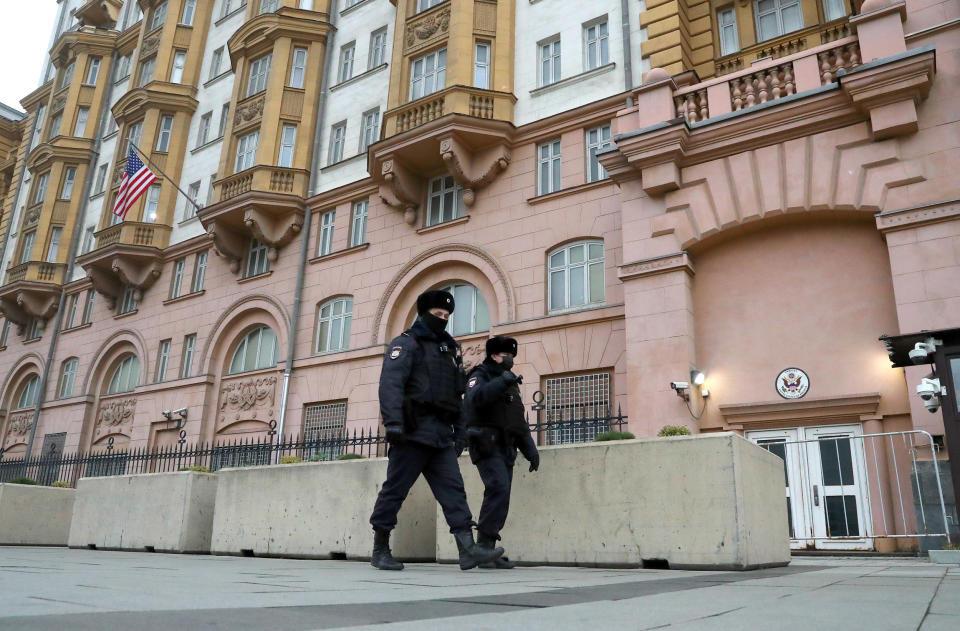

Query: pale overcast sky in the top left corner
[[0, 0, 57, 110]]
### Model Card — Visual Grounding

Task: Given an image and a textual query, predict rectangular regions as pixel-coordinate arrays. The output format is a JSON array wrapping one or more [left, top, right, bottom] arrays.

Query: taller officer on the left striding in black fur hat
[[370, 291, 503, 570]]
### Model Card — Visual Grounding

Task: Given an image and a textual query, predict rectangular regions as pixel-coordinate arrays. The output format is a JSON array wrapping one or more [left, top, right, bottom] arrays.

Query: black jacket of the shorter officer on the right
[[464, 358, 537, 464]]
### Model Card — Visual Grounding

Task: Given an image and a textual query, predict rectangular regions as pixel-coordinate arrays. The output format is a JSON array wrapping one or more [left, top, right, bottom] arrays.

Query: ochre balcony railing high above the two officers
[[384, 85, 516, 136]]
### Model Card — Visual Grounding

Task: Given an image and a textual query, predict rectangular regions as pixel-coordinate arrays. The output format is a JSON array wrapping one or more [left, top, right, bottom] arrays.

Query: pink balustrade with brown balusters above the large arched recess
[[674, 37, 861, 123]]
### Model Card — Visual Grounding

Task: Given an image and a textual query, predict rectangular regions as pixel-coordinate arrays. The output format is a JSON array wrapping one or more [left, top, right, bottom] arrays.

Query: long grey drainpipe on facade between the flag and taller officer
[[276, 3, 337, 450]]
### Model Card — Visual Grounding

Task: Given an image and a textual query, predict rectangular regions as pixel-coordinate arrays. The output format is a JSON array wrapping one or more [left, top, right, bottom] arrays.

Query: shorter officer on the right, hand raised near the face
[[464, 335, 540, 569]]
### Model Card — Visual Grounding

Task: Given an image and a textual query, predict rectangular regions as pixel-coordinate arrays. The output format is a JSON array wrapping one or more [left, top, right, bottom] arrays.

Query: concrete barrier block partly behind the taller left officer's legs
[[212, 458, 437, 561]]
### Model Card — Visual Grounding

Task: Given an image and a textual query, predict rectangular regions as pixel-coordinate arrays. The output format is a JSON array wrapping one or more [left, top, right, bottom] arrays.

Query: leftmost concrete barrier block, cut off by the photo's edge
[[0, 484, 76, 546]]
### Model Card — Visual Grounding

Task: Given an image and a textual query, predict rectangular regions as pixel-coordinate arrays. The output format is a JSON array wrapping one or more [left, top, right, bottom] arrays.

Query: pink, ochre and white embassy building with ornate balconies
[[0, 0, 960, 549]]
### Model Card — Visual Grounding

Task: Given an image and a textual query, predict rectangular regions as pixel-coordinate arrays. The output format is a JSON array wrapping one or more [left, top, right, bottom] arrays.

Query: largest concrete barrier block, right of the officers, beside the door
[[437, 433, 790, 570]]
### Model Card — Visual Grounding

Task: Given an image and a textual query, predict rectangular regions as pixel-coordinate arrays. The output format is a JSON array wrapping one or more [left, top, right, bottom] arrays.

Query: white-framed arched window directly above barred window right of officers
[[548, 241, 604, 311]]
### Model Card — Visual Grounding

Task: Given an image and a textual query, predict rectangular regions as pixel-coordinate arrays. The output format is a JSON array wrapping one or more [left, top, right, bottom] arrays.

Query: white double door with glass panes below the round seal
[[746, 425, 873, 550]]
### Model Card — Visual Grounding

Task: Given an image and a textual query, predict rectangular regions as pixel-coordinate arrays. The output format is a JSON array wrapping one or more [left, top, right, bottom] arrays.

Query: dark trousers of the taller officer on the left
[[370, 442, 473, 532]]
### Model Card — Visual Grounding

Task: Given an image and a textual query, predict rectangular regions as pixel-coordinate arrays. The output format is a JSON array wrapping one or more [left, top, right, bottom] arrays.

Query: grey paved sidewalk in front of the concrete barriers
[[0, 547, 960, 631]]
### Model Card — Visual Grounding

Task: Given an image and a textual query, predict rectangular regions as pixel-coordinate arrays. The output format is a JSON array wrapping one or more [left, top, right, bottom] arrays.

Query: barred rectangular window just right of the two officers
[[543, 372, 610, 445]]
